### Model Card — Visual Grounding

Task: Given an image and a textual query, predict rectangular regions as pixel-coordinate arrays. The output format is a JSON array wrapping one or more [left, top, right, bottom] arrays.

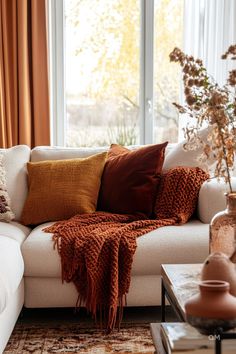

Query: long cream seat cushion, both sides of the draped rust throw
[[22, 220, 209, 277]]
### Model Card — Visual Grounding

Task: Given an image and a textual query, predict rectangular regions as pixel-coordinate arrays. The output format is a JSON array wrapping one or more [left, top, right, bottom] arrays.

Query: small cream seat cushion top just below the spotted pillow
[[0, 221, 31, 245]]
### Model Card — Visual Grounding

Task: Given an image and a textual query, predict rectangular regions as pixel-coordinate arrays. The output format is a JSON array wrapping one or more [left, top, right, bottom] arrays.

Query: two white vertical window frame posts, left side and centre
[[48, 0, 157, 146]]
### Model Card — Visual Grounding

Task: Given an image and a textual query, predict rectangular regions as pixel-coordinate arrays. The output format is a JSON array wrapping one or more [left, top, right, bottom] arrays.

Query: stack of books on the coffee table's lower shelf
[[160, 322, 236, 354]]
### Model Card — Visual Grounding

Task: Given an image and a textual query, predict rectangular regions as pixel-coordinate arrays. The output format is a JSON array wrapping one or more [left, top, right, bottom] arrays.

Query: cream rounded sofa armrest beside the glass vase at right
[[198, 177, 236, 224]]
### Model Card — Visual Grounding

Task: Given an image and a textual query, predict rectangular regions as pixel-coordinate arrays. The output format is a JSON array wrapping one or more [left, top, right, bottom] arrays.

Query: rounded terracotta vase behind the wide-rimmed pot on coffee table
[[201, 252, 236, 296]]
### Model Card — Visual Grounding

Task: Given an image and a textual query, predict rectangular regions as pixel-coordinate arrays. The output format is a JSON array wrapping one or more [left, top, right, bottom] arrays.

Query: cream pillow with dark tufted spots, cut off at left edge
[[0, 154, 15, 222]]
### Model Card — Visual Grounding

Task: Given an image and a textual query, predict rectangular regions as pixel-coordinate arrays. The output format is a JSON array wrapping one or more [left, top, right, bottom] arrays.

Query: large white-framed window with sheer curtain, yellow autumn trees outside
[[48, 0, 236, 147]]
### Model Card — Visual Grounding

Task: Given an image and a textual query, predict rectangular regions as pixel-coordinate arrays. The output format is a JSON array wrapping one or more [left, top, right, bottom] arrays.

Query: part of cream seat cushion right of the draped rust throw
[[132, 220, 209, 275]]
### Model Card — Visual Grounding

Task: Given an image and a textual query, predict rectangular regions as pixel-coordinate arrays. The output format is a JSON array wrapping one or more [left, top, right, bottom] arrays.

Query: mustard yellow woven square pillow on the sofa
[[21, 152, 107, 225]]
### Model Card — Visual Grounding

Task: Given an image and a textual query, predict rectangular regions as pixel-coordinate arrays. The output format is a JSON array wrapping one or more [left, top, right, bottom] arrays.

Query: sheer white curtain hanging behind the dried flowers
[[179, 0, 236, 140]]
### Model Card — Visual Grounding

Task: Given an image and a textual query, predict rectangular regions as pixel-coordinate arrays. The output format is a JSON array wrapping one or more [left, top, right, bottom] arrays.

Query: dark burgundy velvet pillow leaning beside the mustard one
[[98, 142, 168, 217]]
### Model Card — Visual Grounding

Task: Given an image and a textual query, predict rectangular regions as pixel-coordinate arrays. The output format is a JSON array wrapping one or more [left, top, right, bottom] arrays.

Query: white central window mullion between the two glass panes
[[140, 0, 154, 144]]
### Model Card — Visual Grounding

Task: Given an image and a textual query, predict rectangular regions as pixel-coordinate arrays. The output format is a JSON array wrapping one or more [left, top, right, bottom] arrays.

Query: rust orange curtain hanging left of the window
[[0, 0, 50, 147]]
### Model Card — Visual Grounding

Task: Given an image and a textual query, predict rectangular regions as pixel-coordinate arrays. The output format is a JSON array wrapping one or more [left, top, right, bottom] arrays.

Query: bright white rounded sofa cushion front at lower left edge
[[0, 237, 24, 313]]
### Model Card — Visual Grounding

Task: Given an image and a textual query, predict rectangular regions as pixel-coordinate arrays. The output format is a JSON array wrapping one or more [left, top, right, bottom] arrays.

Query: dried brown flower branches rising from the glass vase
[[170, 44, 236, 192]]
